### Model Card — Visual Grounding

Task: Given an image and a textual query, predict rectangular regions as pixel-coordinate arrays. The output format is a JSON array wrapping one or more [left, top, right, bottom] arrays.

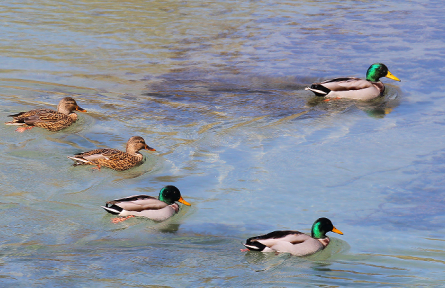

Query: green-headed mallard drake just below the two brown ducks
[[101, 185, 190, 223]]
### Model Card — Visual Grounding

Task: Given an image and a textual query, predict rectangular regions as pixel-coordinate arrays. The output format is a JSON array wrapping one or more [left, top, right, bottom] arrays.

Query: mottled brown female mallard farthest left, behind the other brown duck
[[5, 97, 87, 132]]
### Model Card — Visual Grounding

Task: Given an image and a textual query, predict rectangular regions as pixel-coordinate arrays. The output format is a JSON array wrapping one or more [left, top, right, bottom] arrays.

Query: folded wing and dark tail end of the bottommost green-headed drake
[[244, 230, 311, 252]]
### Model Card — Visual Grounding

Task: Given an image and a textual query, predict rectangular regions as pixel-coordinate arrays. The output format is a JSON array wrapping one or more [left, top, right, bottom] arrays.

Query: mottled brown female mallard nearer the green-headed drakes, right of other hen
[[68, 136, 156, 171]]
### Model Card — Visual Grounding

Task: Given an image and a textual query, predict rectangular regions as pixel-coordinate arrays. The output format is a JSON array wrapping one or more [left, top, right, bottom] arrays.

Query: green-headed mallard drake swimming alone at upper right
[[305, 63, 400, 100]]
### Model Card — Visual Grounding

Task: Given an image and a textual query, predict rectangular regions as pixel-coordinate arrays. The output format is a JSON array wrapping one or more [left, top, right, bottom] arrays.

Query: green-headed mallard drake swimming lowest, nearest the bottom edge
[[241, 218, 343, 256]]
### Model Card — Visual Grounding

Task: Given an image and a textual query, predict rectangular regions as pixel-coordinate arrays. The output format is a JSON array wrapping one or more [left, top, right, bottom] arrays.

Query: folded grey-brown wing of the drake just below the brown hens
[[105, 195, 168, 212]]
